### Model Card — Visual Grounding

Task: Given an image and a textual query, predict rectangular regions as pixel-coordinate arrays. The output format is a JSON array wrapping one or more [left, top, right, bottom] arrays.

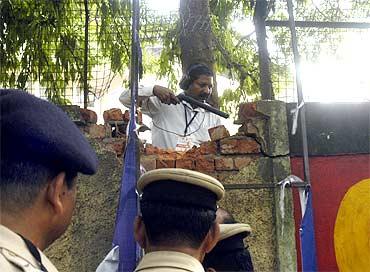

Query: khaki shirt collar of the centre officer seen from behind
[[135, 251, 204, 272]]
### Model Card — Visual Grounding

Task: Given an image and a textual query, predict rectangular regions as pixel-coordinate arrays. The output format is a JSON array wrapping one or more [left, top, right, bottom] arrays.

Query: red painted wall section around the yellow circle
[[291, 154, 370, 271]]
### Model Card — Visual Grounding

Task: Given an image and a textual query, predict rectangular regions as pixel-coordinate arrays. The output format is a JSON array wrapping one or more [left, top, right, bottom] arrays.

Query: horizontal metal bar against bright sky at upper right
[[266, 20, 370, 29]]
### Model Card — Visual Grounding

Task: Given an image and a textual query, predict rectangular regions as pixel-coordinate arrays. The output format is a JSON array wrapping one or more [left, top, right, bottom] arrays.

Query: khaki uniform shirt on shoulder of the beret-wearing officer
[[0, 224, 58, 272]]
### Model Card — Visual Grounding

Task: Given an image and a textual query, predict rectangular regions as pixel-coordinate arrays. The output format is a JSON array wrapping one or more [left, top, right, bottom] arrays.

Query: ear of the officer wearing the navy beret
[[46, 172, 68, 214]]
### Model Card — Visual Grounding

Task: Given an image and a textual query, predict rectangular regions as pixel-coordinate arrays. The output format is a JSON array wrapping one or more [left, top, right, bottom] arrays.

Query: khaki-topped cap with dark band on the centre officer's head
[[137, 168, 225, 211]]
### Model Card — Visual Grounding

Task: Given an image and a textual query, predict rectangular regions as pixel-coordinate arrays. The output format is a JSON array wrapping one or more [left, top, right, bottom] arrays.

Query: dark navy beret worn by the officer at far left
[[0, 89, 98, 175]]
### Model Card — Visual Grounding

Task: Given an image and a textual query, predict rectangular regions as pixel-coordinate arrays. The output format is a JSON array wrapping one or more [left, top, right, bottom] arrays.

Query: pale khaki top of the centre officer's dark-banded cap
[[137, 168, 225, 200]]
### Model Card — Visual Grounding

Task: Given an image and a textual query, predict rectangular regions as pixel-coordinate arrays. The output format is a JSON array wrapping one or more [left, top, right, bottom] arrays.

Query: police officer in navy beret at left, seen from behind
[[0, 89, 97, 272]]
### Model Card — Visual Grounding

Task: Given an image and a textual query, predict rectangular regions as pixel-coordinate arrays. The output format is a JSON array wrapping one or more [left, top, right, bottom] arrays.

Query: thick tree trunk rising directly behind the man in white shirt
[[179, 0, 219, 108]]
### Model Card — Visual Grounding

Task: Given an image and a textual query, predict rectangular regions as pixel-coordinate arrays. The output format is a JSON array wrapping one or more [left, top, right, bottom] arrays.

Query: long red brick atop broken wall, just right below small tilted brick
[[220, 137, 260, 154]]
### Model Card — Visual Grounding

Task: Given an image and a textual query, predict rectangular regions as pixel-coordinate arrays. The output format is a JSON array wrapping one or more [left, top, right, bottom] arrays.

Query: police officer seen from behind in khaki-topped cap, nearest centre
[[134, 168, 224, 272]]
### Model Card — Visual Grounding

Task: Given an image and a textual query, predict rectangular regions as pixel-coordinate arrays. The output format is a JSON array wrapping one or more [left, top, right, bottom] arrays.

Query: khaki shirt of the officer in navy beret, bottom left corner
[[0, 225, 58, 272]]
